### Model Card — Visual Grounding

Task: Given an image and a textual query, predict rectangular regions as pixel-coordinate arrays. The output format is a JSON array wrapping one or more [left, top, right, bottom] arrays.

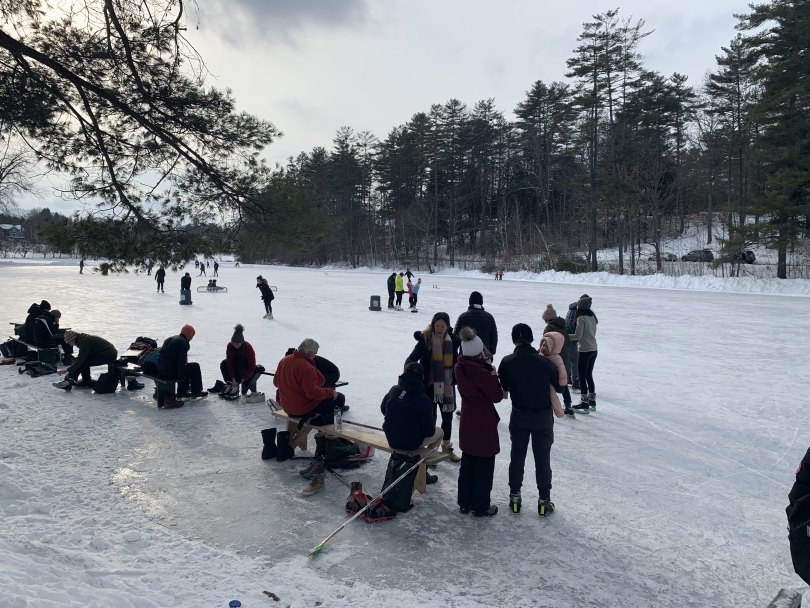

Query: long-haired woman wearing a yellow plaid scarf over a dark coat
[[405, 312, 461, 462]]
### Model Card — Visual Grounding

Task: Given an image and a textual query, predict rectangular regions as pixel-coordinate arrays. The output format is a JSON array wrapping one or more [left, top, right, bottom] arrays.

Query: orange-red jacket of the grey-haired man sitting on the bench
[[273, 350, 334, 417]]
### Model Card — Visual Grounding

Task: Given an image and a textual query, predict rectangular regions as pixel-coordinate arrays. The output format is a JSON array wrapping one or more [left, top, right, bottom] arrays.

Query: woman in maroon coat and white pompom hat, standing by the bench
[[455, 327, 503, 517]]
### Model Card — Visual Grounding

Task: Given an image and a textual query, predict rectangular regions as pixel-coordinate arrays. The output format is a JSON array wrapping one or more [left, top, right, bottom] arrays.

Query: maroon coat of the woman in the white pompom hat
[[456, 355, 503, 458]]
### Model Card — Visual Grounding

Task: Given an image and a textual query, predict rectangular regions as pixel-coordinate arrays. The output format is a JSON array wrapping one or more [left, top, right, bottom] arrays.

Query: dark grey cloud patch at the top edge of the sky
[[200, 0, 368, 44]]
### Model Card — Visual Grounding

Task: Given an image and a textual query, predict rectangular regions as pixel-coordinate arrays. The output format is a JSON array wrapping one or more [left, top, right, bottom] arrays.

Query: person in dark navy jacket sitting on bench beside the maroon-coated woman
[[380, 361, 444, 483]]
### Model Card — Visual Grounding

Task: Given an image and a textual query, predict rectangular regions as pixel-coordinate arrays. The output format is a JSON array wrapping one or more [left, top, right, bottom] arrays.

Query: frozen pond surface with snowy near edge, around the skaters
[[0, 264, 810, 608]]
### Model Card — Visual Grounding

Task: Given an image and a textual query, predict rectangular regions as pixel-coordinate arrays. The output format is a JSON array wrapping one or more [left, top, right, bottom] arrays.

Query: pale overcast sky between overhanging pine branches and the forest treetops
[[26, 0, 747, 211]]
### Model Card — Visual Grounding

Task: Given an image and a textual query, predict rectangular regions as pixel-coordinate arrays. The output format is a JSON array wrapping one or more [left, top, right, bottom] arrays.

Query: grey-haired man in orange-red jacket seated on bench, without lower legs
[[273, 338, 346, 426]]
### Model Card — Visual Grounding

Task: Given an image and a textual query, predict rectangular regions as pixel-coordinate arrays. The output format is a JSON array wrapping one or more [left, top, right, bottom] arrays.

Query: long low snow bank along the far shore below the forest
[[323, 266, 810, 296]]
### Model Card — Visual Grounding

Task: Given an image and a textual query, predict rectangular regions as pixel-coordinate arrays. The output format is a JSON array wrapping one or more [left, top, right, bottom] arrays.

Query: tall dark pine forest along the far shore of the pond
[[234, 0, 810, 277]]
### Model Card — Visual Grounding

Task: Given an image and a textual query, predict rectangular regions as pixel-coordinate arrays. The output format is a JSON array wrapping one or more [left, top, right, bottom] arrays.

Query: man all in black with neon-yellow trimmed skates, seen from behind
[[496, 323, 562, 517]]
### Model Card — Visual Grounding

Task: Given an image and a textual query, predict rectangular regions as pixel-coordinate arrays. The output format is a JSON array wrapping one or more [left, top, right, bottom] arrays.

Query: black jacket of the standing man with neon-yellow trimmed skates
[[498, 344, 562, 414]]
